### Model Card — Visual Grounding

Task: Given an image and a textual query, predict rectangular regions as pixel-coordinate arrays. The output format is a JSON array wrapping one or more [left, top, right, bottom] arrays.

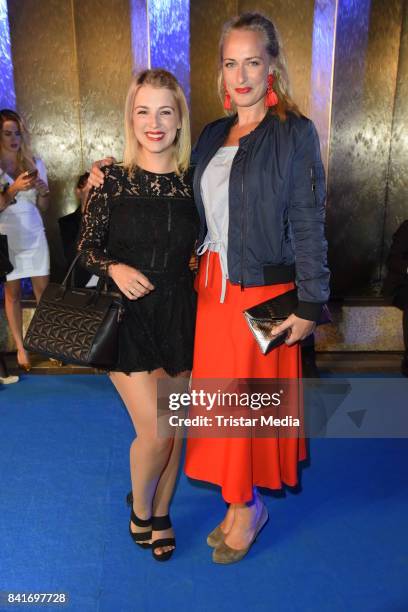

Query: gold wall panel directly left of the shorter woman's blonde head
[[74, 0, 132, 168]]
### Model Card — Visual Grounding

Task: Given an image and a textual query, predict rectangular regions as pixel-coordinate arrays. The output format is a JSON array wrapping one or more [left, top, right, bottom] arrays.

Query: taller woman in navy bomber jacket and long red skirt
[[185, 13, 329, 563]]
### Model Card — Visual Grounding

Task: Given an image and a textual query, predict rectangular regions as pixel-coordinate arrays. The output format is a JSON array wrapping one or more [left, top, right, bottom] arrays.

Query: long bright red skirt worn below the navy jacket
[[185, 251, 306, 503]]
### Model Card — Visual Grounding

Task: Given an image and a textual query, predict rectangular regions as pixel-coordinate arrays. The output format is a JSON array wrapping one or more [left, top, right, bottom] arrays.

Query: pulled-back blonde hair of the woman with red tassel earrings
[[217, 13, 301, 120]]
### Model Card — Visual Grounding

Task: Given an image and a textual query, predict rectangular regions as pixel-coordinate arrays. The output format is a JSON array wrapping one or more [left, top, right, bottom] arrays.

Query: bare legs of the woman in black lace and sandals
[[110, 369, 181, 554]]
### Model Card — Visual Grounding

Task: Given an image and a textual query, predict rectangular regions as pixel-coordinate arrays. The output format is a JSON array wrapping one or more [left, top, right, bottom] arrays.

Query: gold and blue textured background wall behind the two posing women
[[0, 0, 408, 297]]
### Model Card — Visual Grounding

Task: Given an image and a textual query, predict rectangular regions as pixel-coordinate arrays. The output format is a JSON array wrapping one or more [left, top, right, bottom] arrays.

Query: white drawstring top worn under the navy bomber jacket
[[197, 146, 238, 302]]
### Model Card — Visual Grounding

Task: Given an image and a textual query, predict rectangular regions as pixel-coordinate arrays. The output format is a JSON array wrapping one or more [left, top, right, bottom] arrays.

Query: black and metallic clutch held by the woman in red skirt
[[243, 289, 331, 355]]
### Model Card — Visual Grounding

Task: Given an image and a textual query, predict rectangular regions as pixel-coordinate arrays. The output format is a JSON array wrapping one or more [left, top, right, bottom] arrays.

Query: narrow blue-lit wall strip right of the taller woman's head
[[310, 0, 338, 175]]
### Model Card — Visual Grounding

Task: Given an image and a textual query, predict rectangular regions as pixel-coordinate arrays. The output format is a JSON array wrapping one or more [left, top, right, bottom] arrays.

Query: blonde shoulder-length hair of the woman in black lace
[[123, 68, 191, 174]]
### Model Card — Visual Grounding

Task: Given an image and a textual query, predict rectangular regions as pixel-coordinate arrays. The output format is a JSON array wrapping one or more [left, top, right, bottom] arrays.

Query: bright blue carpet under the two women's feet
[[0, 376, 408, 612]]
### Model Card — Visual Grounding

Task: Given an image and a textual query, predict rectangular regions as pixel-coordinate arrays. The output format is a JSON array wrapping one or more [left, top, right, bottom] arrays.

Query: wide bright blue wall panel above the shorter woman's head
[[147, 0, 190, 101]]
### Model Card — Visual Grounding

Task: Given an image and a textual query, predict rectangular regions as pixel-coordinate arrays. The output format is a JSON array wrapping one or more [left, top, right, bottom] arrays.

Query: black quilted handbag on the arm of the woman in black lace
[[24, 254, 124, 369]]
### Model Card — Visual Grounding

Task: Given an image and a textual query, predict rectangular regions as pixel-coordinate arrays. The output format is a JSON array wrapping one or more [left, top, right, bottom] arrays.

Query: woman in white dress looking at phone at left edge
[[0, 109, 50, 371]]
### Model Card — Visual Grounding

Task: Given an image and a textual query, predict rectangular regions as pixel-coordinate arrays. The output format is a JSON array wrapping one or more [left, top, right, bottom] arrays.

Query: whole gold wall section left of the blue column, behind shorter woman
[[8, 0, 132, 277]]
